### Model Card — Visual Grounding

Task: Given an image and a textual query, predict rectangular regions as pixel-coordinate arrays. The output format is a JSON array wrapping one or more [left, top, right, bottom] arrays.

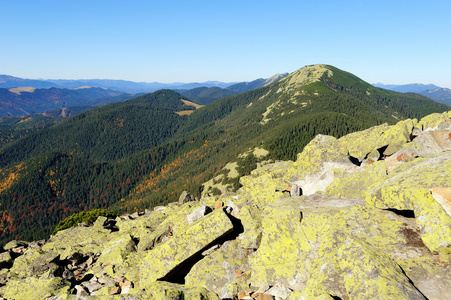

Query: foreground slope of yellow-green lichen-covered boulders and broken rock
[[0, 111, 451, 300]]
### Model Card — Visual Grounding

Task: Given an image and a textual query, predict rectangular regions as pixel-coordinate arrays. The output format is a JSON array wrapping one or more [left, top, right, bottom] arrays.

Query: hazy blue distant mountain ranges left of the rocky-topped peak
[[0, 73, 288, 113]]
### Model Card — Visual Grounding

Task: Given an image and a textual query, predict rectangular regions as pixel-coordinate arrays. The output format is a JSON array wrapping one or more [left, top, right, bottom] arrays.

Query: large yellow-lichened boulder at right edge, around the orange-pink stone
[[366, 151, 451, 252]]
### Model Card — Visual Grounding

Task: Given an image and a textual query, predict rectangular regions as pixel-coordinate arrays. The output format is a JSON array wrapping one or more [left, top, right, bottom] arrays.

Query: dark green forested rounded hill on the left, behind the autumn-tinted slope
[[0, 90, 195, 166]]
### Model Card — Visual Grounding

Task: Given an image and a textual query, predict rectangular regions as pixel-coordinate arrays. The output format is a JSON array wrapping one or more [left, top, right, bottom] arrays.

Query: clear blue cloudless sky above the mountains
[[0, 0, 451, 88]]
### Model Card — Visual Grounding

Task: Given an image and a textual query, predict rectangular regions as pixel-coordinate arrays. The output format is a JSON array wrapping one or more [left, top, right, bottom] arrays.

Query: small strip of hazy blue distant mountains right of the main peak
[[373, 83, 451, 106]]
